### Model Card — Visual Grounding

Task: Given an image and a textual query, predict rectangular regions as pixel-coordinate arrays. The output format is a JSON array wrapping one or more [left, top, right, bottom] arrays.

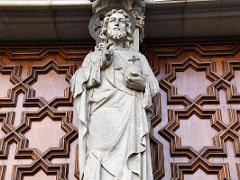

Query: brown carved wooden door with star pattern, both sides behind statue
[[0, 42, 240, 180]]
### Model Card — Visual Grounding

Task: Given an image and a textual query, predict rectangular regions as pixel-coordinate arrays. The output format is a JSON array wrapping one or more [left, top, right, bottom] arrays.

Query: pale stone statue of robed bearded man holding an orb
[[71, 9, 159, 180]]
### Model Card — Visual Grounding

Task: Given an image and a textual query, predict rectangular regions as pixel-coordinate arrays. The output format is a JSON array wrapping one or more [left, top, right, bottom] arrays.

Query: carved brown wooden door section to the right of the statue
[[145, 42, 240, 180]]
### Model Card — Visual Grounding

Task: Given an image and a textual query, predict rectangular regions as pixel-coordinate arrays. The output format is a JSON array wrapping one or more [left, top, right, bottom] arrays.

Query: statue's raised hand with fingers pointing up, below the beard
[[100, 43, 113, 70]]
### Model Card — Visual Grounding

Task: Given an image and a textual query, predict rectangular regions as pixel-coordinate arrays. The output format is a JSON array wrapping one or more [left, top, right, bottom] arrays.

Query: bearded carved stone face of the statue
[[107, 13, 127, 40]]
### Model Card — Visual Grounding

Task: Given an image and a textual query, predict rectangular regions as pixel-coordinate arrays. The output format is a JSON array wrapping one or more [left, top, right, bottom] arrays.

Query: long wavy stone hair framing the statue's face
[[96, 9, 133, 49]]
